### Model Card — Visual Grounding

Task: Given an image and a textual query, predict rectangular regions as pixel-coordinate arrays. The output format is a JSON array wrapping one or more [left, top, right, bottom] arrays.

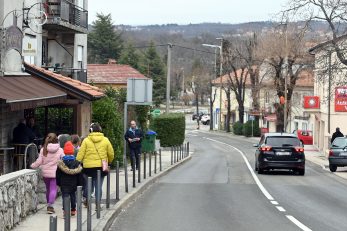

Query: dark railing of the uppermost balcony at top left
[[46, 0, 88, 29]]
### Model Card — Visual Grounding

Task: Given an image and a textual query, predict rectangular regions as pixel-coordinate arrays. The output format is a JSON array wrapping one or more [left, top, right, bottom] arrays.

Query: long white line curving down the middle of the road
[[202, 137, 312, 231]]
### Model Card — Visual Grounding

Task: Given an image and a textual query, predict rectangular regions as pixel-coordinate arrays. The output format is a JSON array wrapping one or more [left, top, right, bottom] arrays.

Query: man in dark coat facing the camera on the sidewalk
[[124, 120, 143, 170]]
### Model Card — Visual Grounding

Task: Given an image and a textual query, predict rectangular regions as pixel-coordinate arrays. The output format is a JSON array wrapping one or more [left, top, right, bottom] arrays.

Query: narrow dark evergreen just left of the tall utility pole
[[141, 42, 166, 107]]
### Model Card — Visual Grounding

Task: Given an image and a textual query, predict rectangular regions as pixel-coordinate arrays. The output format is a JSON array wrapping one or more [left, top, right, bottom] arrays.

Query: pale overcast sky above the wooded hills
[[88, 0, 287, 25]]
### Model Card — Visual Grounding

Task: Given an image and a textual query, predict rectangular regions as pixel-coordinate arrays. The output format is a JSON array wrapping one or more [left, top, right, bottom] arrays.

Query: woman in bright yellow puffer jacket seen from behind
[[76, 123, 114, 205]]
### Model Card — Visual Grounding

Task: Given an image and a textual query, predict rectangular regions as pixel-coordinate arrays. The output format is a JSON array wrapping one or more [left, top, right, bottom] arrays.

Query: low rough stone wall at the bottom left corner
[[0, 169, 40, 231]]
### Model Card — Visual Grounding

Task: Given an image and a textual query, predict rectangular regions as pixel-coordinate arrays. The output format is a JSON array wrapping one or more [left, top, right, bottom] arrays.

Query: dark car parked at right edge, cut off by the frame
[[329, 137, 347, 172]]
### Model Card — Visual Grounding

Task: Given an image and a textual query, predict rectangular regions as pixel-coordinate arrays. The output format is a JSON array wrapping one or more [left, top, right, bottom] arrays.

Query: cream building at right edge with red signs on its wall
[[306, 35, 347, 155]]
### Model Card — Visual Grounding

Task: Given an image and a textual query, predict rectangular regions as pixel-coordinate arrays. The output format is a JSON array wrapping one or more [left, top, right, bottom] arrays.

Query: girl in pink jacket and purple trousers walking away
[[31, 133, 64, 214]]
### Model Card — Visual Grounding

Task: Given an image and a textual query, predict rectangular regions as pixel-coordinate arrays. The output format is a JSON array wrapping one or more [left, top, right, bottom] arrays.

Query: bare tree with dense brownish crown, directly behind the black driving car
[[262, 25, 313, 132]]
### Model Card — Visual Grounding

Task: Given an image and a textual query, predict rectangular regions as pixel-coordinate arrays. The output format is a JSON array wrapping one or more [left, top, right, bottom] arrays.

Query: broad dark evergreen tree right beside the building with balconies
[[88, 13, 123, 63]]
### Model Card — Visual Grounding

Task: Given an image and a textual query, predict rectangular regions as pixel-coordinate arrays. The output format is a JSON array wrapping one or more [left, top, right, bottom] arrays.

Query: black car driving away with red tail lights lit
[[253, 133, 305, 176]]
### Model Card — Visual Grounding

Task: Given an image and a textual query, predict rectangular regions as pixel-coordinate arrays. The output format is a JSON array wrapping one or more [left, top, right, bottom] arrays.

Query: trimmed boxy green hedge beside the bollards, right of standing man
[[150, 113, 186, 147]]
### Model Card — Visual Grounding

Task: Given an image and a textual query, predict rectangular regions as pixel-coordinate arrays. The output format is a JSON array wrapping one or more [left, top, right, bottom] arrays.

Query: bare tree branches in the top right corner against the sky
[[282, 0, 347, 65]]
